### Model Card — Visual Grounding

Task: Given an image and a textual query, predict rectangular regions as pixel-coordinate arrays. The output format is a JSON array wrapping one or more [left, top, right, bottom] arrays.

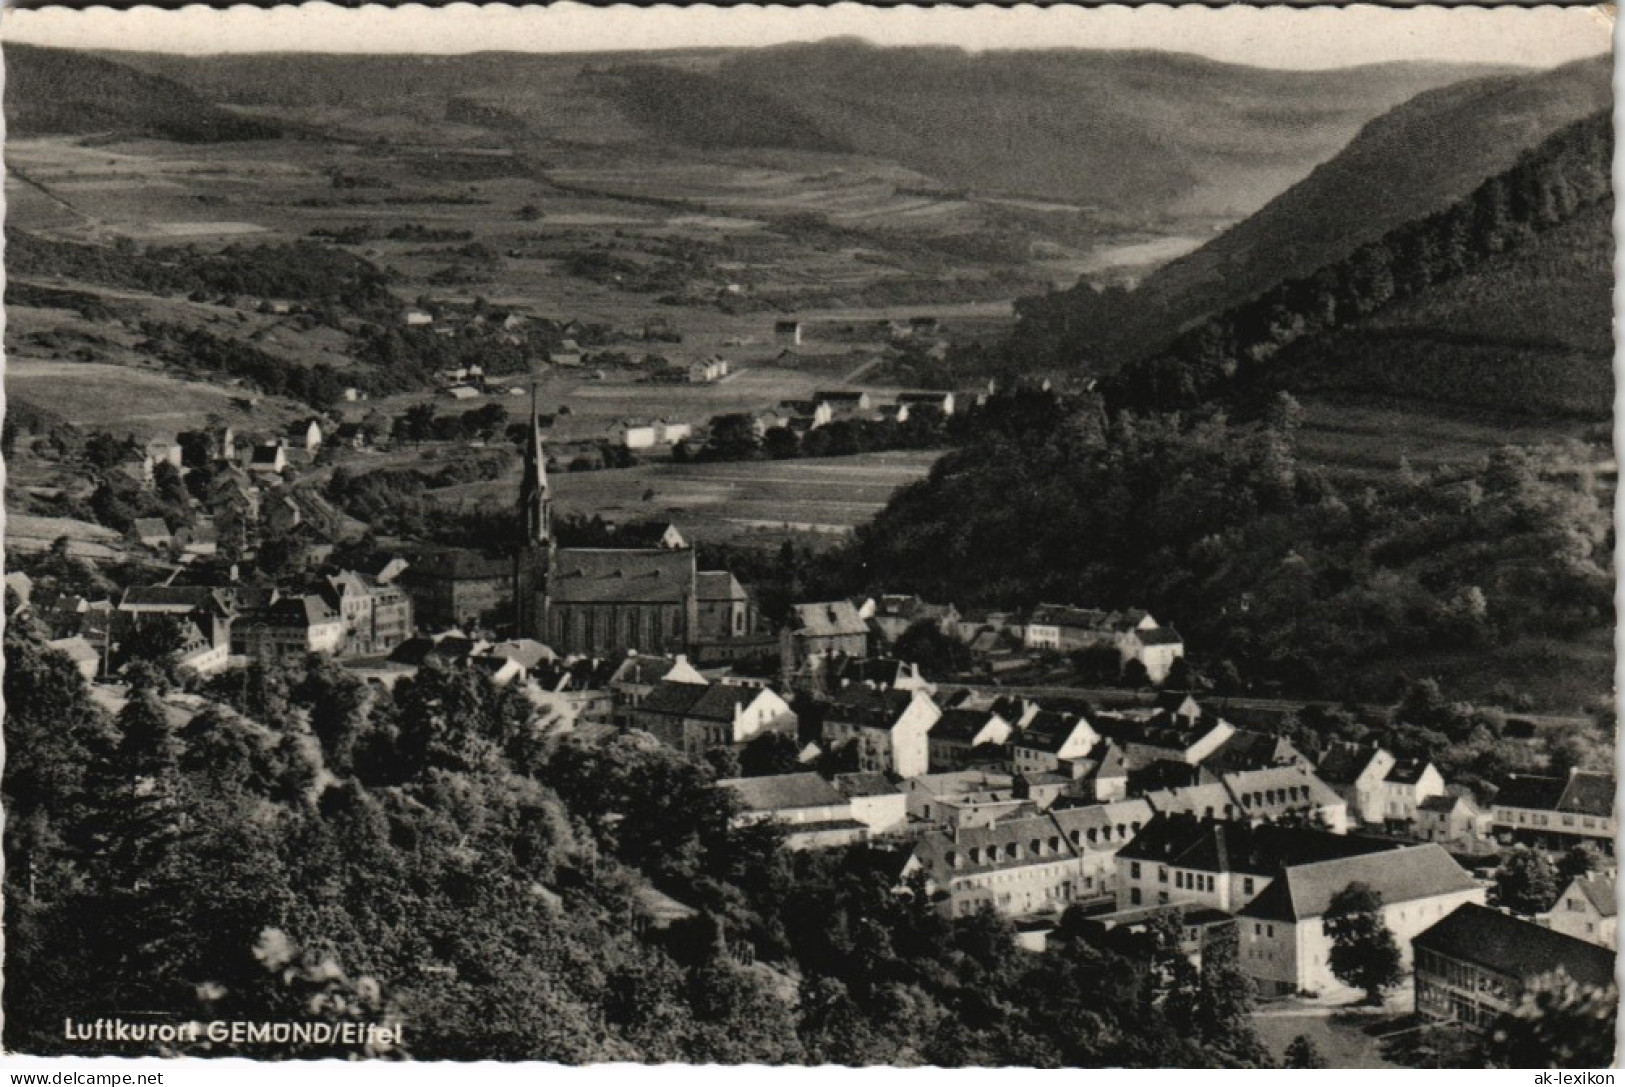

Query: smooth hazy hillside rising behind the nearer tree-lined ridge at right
[[1021, 57, 1612, 369]]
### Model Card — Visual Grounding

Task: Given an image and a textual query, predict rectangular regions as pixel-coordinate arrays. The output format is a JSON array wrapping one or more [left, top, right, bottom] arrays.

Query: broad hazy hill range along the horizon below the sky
[[101, 41, 1492, 226]]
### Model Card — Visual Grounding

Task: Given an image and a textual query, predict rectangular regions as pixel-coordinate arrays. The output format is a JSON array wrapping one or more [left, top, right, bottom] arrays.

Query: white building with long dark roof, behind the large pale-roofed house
[[1116, 812, 1399, 913]]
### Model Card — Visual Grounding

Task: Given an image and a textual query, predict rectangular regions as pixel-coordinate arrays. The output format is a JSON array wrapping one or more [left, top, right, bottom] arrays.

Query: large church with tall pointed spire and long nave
[[514, 396, 756, 658]]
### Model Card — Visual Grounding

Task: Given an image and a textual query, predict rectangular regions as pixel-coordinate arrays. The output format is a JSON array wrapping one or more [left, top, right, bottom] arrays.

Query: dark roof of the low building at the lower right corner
[[1410, 892, 1614, 988]]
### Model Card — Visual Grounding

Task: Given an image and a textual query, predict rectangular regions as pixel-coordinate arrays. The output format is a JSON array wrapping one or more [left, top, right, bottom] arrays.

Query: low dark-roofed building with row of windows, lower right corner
[[1412, 903, 1615, 1029]]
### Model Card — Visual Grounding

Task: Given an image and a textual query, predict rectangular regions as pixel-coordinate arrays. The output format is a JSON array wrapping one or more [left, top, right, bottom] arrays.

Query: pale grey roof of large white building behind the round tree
[[1240, 842, 1477, 921]]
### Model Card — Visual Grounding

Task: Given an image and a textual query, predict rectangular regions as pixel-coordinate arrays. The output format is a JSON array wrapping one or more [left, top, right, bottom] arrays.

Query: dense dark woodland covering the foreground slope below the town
[[3, 623, 1268, 1068]]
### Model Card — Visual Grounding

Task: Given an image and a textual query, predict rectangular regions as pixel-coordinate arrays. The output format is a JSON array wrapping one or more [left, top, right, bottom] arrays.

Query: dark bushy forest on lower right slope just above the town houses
[[834, 385, 1614, 697]]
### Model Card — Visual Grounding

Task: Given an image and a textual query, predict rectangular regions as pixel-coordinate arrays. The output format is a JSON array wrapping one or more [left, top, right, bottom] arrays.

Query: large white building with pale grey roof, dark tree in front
[[1237, 843, 1485, 994]]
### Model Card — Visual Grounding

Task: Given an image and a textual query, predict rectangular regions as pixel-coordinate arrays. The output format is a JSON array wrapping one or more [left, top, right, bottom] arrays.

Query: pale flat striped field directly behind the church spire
[[434, 452, 941, 541]]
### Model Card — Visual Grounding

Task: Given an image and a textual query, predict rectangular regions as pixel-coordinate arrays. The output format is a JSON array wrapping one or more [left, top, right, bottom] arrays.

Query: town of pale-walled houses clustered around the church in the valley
[[7, 373, 1617, 1059]]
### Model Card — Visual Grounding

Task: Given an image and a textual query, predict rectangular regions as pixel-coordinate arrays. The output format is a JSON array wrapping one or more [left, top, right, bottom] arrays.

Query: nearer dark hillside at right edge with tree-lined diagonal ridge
[[1105, 110, 1614, 419]]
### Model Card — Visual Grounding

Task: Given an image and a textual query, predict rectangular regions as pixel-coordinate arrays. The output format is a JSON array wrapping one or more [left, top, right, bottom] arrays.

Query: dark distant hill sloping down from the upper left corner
[[5, 45, 280, 143]]
